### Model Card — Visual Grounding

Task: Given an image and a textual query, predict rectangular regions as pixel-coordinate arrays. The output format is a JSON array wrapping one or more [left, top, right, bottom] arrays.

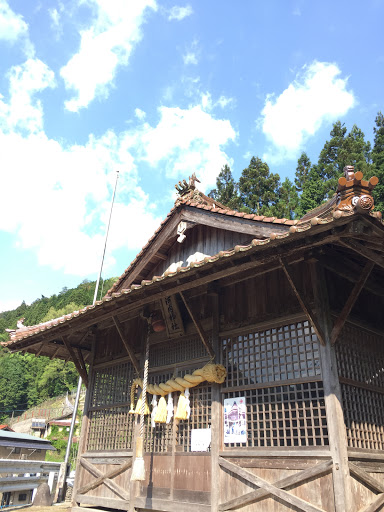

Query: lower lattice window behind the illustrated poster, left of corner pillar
[[224, 382, 328, 447]]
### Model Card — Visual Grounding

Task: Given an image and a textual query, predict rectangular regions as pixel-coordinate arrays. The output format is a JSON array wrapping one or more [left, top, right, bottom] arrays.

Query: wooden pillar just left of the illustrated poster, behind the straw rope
[[211, 291, 222, 512]]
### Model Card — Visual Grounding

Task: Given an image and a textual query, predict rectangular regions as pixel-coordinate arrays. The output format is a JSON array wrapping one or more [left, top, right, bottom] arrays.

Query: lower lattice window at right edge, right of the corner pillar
[[341, 384, 384, 450]]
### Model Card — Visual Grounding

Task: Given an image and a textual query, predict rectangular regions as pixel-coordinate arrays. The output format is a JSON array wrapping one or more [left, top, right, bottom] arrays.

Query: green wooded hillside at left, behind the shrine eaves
[[0, 278, 116, 423]]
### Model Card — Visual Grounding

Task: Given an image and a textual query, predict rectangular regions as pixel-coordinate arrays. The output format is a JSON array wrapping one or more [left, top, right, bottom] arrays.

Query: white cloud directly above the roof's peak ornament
[[136, 94, 236, 189]]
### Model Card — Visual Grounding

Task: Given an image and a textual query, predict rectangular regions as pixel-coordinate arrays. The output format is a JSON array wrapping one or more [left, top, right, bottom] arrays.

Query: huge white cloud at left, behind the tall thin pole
[[0, 59, 160, 276]]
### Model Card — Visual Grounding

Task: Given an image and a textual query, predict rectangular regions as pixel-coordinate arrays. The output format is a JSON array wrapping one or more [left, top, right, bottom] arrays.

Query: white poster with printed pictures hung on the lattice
[[224, 396, 247, 443]]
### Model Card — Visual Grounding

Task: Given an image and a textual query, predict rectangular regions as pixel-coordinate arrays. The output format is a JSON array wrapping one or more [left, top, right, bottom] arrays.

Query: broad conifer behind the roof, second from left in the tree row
[[239, 157, 280, 215]]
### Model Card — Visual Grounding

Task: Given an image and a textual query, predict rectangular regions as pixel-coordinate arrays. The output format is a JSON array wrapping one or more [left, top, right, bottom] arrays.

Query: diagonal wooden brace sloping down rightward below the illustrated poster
[[219, 457, 324, 512]]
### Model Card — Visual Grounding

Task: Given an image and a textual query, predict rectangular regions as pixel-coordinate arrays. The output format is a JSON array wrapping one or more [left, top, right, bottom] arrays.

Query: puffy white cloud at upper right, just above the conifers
[[259, 61, 356, 161]]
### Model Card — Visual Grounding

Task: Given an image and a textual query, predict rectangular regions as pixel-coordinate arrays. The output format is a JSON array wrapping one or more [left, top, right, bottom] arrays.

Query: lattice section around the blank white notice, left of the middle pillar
[[176, 383, 212, 452]]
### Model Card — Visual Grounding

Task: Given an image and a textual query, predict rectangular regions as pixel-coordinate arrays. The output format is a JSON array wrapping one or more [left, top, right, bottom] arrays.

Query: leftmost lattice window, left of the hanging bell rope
[[87, 363, 134, 450]]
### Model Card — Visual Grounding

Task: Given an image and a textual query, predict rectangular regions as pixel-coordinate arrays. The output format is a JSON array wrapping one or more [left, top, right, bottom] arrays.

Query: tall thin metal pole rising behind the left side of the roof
[[56, 171, 119, 503]]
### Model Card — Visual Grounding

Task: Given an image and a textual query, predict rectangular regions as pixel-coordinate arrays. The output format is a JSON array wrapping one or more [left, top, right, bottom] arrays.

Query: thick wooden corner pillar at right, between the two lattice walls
[[311, 261, 352, 512]]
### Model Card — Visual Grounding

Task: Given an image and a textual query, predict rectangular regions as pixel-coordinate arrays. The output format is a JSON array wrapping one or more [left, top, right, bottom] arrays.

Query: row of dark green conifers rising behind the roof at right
[[209, 112, 384, 219]]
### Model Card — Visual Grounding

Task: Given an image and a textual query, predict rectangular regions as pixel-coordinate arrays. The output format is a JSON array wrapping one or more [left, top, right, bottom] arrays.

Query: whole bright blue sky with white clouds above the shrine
[[0, 0, 384, 311]]
